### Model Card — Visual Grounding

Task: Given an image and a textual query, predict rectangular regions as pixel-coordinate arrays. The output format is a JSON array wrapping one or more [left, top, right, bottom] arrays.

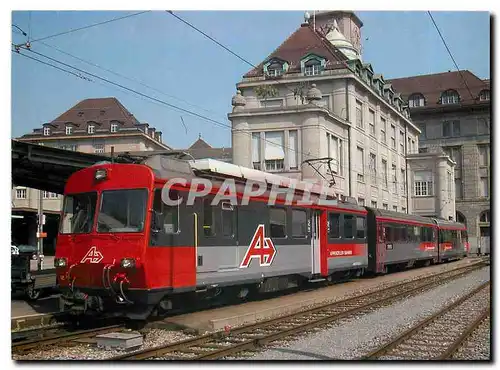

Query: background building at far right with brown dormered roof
[[391, 71, 493, 252]]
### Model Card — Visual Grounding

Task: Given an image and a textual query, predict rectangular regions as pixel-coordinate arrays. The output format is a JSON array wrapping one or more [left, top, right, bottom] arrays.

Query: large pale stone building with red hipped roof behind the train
[[229, 12, 420, 212]]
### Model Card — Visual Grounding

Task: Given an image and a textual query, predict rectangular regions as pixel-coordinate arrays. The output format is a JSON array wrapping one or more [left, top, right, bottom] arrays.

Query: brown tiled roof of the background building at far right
[[386, 70, 490, 107]]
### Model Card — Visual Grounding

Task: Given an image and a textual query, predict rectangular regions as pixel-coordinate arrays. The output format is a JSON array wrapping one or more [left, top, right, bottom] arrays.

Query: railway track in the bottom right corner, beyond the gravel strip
[[362, 282, 490, 360]]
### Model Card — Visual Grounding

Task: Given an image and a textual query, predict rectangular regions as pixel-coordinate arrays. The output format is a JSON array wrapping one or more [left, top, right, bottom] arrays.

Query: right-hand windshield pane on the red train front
[[97, 189, 148, 233]]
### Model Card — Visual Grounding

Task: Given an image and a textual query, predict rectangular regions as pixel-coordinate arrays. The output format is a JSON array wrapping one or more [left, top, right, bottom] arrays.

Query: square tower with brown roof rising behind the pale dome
[[309, 10, 363, 55]]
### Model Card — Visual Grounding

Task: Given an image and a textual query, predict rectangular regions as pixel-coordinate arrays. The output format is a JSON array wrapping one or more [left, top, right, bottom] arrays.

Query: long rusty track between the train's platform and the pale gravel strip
[[109, 263, 485, 361]]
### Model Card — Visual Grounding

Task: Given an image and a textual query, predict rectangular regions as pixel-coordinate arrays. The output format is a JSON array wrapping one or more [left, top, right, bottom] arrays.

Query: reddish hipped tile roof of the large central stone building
[[243, 23, 347, 77]]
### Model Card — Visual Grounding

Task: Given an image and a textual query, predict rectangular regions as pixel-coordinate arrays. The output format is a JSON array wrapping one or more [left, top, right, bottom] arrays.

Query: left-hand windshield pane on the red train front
[[60, 192, 97, 234]]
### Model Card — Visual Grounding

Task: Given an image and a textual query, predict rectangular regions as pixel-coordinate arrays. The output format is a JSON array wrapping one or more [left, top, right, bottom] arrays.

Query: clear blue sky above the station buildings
[[11, 11, 490, 149]]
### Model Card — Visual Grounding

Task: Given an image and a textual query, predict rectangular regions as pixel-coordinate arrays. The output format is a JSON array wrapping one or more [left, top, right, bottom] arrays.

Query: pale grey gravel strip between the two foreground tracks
[[242, 267, 490, 360]]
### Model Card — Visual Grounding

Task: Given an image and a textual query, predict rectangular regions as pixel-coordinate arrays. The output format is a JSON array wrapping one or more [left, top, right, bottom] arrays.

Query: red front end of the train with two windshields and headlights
[[54, 164, 154, 318]]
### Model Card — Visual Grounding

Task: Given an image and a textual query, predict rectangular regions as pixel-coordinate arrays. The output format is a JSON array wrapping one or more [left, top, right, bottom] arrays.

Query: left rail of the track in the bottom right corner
[[360, 281, 491, 360]]
